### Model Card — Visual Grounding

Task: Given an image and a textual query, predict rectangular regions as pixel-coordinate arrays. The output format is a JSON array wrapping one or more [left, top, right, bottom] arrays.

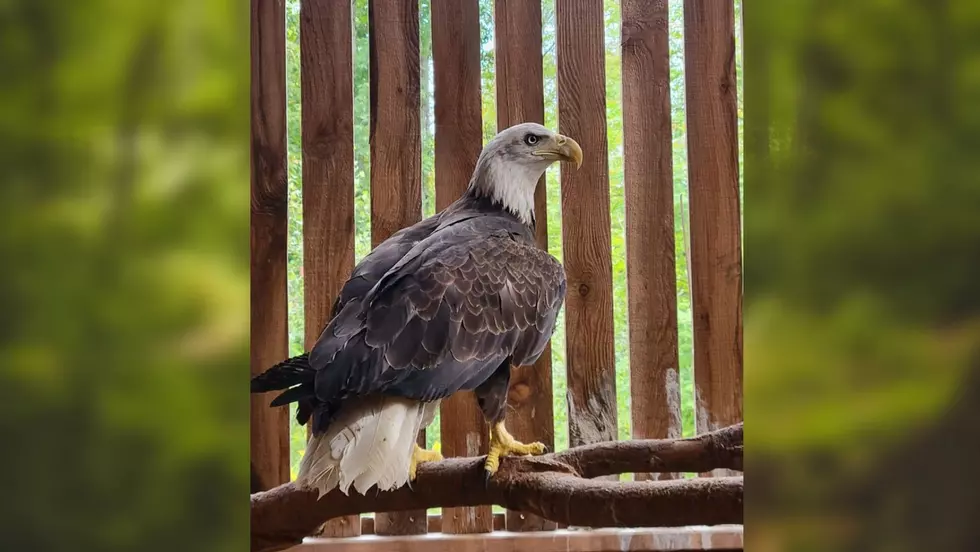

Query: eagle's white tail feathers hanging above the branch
[[296, 397, 439, 496]]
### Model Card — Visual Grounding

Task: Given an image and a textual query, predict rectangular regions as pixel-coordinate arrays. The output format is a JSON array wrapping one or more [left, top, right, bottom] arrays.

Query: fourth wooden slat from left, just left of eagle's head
[[432, 0, 493, 533]]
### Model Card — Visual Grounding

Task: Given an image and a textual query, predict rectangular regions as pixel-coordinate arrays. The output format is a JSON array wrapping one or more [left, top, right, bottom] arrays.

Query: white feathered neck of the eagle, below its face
[[467, 156, 544, 228]]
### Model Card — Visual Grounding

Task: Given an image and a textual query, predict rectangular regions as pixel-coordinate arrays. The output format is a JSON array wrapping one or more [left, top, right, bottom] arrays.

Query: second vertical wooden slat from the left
[[300, 0, 361, 536]]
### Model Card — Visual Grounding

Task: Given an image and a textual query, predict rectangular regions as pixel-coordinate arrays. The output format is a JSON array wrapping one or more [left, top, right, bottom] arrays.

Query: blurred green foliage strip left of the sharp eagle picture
[[0, 0, 249, 552]]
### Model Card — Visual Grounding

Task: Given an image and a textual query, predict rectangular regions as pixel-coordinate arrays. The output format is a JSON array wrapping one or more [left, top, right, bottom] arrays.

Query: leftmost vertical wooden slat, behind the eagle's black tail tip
[[249, 0, 289, 488]]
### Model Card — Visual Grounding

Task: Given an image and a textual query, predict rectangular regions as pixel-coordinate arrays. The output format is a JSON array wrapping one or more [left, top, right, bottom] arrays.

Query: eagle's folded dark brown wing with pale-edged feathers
[[311, 217, 566, 412]]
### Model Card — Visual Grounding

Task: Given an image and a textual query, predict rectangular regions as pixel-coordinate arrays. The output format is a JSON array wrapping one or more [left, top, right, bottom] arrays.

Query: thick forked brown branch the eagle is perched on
[[251, 424, 742, 552]]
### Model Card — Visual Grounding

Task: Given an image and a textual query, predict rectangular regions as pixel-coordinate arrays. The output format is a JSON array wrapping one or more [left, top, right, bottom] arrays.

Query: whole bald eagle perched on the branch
[[251, 123, 582, 496]]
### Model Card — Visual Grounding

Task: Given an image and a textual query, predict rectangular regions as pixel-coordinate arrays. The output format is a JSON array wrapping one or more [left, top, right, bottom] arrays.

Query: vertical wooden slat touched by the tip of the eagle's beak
[[555, 0, 617, 447]]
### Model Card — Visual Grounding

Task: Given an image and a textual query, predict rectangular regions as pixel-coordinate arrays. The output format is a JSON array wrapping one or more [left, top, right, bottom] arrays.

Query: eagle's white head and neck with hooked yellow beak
[[470, 123, 582, 225]]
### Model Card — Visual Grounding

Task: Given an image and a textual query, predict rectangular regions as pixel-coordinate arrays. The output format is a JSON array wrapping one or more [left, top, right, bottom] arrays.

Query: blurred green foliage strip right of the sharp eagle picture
[[744, 0, 980, 551]]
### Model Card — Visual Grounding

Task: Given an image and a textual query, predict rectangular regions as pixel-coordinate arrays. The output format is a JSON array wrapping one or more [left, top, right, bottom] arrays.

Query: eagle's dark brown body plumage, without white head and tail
[[252, 192, 566, 434]]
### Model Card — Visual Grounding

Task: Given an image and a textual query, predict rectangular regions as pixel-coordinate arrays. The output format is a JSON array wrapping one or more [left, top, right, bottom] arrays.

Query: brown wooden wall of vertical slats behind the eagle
[[251, 0, 742, 550]]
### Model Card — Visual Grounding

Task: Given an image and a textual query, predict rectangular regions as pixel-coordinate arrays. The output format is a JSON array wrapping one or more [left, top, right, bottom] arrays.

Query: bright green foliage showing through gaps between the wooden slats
[[286, 0, 741, 474]]
